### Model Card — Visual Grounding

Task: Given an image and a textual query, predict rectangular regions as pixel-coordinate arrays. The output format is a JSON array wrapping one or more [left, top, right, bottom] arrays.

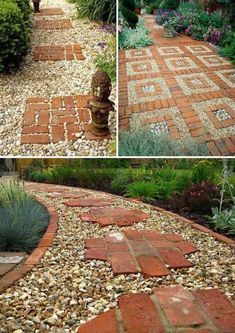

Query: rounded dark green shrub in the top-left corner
[[0, 0, 29, 72]]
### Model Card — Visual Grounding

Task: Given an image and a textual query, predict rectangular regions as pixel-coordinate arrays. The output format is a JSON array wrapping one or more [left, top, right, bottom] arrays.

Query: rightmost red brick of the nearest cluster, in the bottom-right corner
[[194, 289, 235, 333]]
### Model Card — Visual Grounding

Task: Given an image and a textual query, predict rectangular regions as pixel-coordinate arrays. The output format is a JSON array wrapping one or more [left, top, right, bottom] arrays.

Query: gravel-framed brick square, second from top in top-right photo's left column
[[126, 60, 159, 75]]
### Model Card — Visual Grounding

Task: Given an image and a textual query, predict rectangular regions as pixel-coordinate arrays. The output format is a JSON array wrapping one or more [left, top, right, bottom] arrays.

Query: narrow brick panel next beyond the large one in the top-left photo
[[33, 44, 85, 61]]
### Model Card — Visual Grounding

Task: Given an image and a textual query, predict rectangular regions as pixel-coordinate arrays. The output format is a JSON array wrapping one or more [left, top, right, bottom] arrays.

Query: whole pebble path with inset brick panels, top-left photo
[[0, 0, 115, 156]]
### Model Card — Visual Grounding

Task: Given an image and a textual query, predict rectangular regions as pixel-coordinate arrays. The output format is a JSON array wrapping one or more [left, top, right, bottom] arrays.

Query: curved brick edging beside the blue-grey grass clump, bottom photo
[[0, 196, 58, 292]]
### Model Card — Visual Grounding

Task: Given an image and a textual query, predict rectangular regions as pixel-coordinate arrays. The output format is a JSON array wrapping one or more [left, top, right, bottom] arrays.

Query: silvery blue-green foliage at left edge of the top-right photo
[[119, 18, 152, 49]]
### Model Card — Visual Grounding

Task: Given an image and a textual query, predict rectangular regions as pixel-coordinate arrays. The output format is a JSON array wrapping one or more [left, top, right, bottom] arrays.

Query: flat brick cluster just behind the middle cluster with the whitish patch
[[81, 207, 149, 227]]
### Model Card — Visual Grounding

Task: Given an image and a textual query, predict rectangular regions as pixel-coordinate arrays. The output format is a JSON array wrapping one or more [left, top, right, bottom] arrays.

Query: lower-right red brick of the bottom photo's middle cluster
[[158, 249, 193, 268]]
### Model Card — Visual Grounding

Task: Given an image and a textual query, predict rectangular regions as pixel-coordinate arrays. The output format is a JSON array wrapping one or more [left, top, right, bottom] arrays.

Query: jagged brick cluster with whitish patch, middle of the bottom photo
[[85, 230, 197, 278]]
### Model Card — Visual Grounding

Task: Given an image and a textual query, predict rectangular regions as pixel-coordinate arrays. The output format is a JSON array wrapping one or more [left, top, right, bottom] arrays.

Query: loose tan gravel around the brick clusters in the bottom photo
[[0, 184, 235, 333]]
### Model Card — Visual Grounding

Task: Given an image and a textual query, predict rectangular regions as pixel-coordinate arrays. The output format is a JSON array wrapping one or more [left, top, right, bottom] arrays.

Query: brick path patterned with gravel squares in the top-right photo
[[119, 15, 235, 155]]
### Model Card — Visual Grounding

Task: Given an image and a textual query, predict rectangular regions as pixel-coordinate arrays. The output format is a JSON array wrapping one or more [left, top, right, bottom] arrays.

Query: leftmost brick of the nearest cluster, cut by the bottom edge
[[77, 310, 119, 333]]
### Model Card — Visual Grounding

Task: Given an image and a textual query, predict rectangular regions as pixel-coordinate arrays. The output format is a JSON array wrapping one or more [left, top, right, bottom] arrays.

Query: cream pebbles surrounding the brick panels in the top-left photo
[[0, 0, 116, 156]]
